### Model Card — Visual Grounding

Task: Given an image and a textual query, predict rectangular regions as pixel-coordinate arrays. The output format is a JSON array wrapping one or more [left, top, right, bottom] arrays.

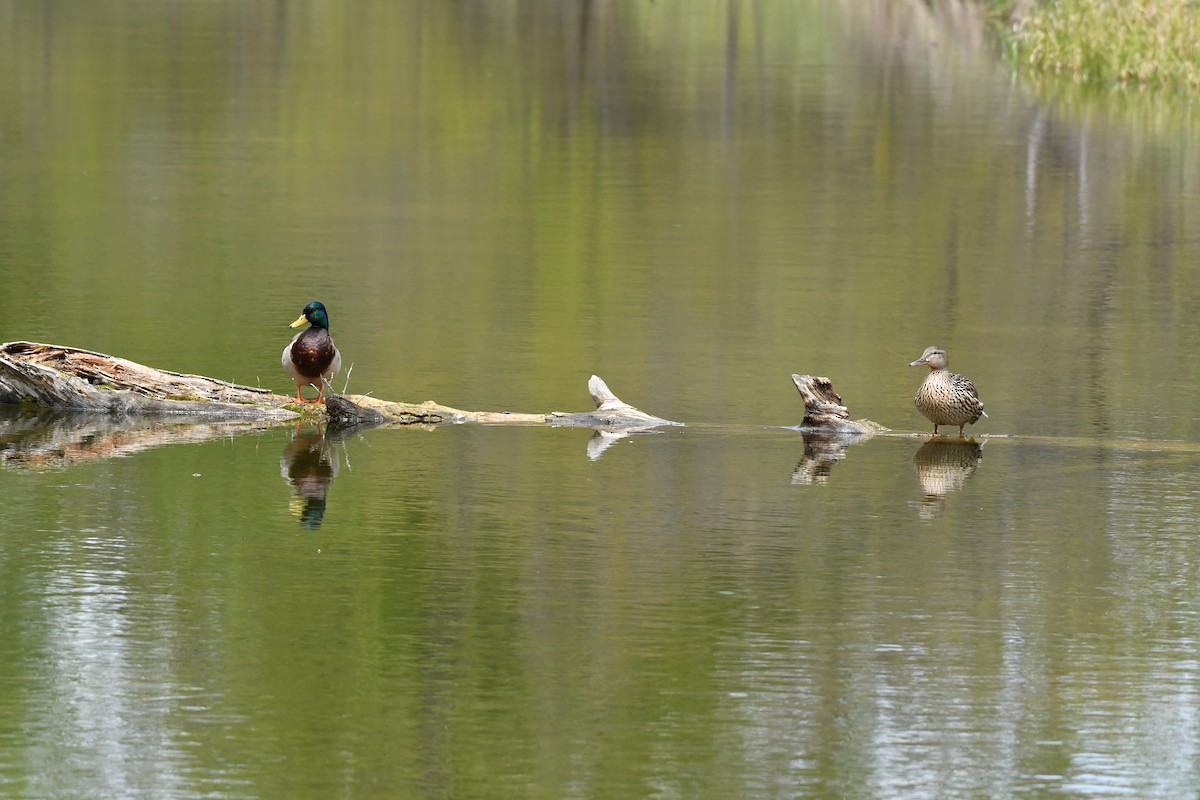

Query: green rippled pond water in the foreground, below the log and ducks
[[0, 419, 1196, 796]]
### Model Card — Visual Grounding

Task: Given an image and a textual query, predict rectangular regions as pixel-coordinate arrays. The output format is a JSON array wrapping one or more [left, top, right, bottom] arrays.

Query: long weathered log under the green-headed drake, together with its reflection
[[0, 342, 679, 468]]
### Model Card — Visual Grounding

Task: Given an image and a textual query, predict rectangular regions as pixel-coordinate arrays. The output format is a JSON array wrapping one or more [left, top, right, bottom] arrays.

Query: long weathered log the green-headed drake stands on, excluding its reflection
[[0, 342, 678, 429]]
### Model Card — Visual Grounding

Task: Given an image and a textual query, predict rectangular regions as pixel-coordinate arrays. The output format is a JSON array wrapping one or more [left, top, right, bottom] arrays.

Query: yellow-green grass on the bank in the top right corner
[[1008, 0, 1200, 92]]
